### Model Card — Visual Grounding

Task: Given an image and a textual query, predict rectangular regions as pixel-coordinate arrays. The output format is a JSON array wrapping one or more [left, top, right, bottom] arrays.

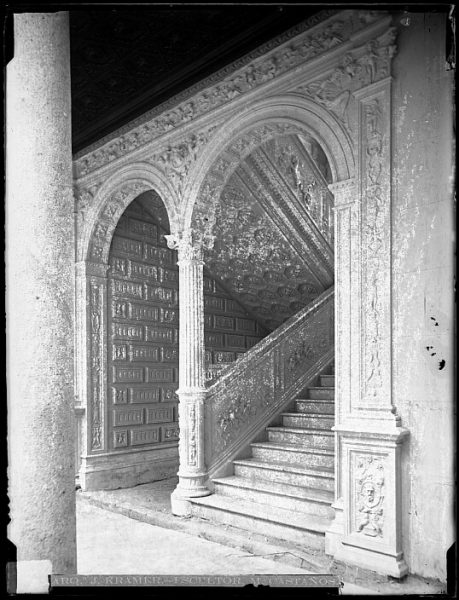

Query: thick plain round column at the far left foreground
[[6, 12, 76, 575]]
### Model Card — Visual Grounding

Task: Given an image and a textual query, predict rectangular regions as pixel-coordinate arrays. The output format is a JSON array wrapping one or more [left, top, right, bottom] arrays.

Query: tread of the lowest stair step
[[190, 494, 330, 533]]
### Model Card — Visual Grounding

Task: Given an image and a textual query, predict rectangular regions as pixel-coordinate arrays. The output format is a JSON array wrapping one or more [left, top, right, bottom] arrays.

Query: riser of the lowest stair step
[[192, 504, 325, 550]]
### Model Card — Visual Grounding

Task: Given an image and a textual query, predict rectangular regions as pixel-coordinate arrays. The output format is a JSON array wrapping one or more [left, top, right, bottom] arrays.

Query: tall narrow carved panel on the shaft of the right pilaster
[[359, 81, 391, 409]]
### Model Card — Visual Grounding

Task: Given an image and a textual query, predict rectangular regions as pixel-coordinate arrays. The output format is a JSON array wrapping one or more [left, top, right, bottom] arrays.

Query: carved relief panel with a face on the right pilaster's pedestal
[[352, 453, 386, 539]]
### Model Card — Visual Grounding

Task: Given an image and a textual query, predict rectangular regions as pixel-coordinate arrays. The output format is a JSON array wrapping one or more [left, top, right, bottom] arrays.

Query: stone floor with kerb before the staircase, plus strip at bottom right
[[77, 478, 444, 595]]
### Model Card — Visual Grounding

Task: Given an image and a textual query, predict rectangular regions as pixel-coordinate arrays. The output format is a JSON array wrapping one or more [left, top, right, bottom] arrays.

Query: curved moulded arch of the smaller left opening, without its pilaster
[[77, 163, 178, 264]]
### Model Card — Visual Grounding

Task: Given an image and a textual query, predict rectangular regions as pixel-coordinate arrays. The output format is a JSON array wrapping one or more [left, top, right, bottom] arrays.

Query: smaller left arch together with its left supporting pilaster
[[75, 163, 178, 472]]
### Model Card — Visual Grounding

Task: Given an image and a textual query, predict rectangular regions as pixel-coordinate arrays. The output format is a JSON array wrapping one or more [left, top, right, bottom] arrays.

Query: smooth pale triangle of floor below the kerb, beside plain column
[[77, 500, 318, 575]]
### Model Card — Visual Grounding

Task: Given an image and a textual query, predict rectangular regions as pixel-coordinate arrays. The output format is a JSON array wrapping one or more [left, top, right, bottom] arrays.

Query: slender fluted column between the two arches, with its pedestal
[[166, 231, 210, 516]]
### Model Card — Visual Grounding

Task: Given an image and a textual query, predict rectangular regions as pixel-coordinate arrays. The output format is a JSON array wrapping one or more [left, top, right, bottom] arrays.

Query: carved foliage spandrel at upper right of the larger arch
[[297, 27, 396, 129]]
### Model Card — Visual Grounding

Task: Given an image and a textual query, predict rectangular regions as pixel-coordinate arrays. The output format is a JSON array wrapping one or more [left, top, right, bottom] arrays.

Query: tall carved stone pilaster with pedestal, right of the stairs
[[326, 77, 408, 578]]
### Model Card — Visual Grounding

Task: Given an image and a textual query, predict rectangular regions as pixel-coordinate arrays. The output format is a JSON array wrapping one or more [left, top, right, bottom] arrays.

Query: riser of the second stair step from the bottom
[[215, 483, 334, 520]]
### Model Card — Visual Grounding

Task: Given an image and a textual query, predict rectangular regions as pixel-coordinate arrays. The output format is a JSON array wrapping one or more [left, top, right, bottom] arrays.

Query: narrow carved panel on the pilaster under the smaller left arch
[[89, 277, 106, 450]]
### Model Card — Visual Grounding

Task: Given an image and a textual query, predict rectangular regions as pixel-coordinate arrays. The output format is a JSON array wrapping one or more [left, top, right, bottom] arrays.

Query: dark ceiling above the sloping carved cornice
[[70, 4, 320, 152]]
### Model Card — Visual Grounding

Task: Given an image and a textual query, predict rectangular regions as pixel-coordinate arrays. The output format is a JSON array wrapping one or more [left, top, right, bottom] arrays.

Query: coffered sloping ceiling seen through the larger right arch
[[205, 135, 333, 331]]
